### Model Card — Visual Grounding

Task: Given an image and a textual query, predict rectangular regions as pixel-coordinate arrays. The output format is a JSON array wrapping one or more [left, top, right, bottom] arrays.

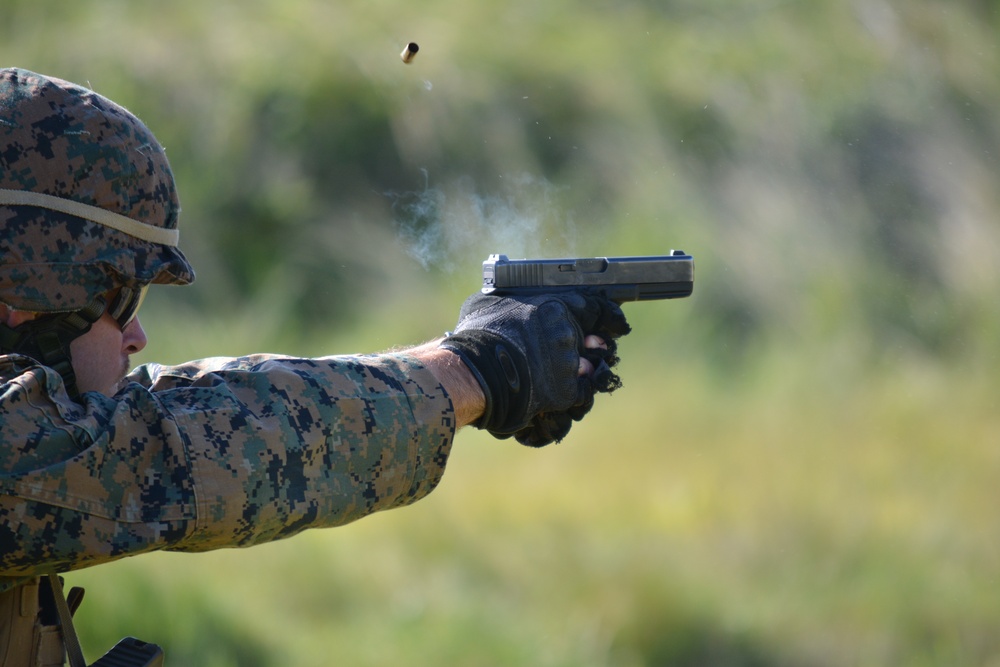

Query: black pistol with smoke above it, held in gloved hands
[[483, 250, 694, 304]]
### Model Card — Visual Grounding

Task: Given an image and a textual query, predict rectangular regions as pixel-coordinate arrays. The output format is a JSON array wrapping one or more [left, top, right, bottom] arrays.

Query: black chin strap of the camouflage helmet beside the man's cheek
[[0, 296, 107, 400]]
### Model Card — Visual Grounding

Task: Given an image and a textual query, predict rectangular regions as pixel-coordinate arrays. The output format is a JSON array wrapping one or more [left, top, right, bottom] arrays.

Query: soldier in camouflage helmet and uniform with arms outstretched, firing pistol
[[0, 69, 628, 666]]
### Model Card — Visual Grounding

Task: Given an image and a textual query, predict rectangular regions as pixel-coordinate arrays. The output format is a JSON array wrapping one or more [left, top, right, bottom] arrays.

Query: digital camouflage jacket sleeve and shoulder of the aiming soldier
[[0, 355, 455, 590]]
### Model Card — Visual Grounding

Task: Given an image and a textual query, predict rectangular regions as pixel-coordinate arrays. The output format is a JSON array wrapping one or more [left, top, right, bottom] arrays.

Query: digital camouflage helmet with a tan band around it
[[0, 69, 194, 313]]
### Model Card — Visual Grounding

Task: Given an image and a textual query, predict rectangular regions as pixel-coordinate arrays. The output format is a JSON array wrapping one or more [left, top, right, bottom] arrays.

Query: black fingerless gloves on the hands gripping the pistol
[[441, 292, 631, 447]]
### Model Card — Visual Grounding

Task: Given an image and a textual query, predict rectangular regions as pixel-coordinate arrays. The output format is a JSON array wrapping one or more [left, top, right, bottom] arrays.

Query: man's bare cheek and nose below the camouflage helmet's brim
[[69, 313, 147, 396]]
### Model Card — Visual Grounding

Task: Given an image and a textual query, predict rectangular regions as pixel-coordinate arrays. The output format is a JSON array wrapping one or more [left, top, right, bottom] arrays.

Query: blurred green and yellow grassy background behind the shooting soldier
[[0, 0, 1000, 667]]
